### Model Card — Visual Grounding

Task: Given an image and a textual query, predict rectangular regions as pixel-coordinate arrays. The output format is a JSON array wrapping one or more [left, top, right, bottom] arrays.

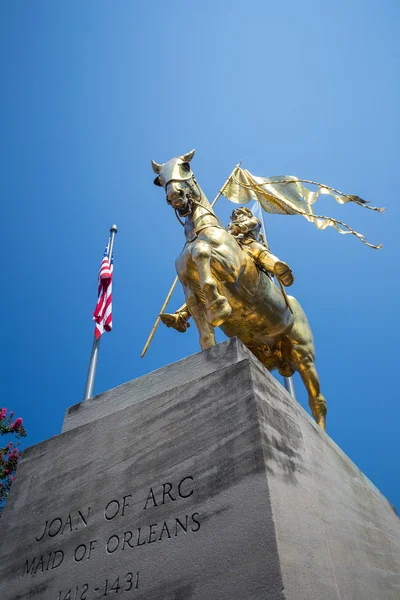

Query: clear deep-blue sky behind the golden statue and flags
[[0, 0, 400, 508]]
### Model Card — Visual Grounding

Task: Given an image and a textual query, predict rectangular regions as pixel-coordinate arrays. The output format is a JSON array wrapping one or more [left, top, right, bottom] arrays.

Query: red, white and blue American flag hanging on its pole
[[93, 240, 114, 340]]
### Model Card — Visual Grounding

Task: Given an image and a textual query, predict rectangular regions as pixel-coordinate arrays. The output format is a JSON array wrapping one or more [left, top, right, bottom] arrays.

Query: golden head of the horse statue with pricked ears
[[151, 150, 201, 217]]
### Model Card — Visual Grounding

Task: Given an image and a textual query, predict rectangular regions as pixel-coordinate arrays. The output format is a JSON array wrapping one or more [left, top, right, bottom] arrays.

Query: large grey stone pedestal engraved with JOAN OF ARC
[[0, 339, 400, 600]]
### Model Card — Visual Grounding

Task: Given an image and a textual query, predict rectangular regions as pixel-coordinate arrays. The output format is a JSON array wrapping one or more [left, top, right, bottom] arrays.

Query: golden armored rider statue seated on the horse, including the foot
[[160, 207, 294, 333]]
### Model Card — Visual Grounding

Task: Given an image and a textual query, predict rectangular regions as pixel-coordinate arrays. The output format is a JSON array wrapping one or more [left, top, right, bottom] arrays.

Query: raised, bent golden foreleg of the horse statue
[[189, 240, 232, 327]]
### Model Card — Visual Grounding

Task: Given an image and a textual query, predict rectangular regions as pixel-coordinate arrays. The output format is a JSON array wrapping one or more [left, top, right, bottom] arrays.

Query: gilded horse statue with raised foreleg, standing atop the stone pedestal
[[152, 150, 326, 430]]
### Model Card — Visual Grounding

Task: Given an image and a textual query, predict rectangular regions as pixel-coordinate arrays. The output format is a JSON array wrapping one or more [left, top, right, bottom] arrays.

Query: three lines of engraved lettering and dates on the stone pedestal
[[21, 475, 201, 588]]
